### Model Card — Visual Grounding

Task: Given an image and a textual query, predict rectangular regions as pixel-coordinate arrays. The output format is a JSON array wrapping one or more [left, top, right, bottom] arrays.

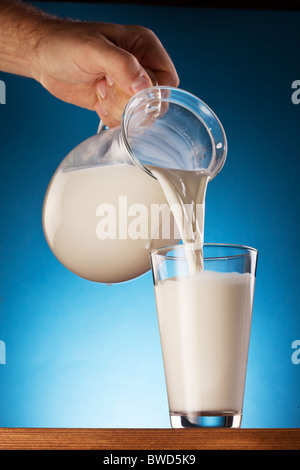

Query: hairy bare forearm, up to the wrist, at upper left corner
[[0, 0, 54, 77]]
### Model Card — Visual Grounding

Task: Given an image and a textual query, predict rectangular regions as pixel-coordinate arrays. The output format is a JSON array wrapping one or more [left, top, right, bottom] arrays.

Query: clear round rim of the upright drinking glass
[[150, 243, 258, 261]]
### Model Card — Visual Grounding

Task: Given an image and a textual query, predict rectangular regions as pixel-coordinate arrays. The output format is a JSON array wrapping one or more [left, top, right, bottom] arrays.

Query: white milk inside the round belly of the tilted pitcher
[[43, 164, 178, 284]]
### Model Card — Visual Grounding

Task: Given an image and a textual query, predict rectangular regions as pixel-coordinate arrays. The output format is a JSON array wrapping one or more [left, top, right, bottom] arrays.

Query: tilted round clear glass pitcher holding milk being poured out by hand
[[43, 86, 227, 284]]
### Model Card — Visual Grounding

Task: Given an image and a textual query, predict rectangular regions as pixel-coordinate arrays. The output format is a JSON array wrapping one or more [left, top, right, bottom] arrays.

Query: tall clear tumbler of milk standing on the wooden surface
[[151, 244, 258, 428]]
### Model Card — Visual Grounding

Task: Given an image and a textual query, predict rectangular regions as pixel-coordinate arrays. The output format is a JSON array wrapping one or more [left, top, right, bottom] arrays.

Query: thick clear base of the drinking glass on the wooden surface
[[170, 412, 242, 428]]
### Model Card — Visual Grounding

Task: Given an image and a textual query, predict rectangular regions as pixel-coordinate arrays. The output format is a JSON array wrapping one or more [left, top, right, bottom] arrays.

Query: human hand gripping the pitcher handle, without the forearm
[[32, 20, 179, 127]]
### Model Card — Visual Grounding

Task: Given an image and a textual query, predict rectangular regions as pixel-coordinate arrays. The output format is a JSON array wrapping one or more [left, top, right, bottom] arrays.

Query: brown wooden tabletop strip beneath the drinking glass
[[0, 428, 300, 450]]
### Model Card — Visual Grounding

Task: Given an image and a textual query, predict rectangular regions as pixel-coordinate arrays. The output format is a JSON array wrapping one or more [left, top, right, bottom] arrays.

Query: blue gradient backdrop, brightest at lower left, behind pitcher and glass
[[0, 3, 300, 428]]
